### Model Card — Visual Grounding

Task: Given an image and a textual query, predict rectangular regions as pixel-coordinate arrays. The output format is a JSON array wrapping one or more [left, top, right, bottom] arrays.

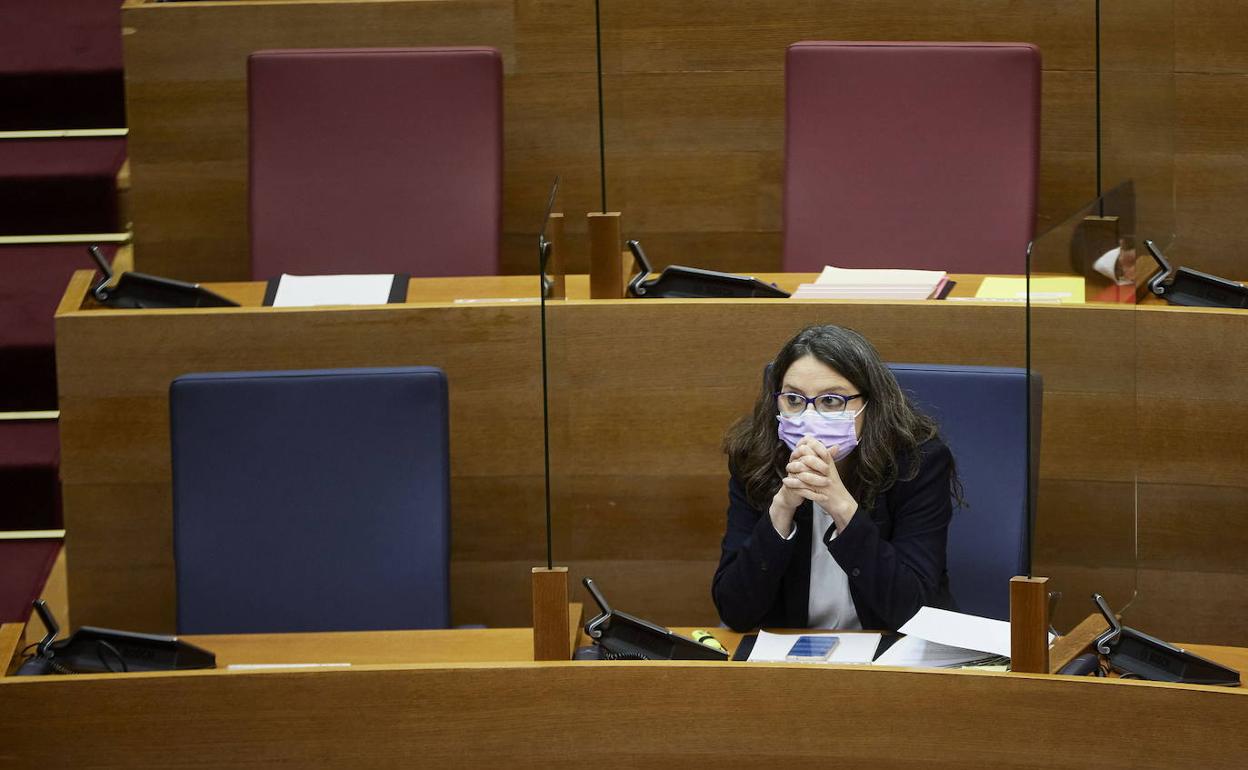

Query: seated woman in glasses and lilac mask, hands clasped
[[711, 326, 961, 630]]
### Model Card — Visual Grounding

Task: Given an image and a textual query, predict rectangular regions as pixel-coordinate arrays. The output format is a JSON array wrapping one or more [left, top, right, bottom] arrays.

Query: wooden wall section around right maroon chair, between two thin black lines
[[602, 0, 1096, 272]]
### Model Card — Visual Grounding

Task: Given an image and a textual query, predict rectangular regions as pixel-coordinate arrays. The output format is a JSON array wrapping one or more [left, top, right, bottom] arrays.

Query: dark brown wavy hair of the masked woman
[[724, 324, 965, 510]]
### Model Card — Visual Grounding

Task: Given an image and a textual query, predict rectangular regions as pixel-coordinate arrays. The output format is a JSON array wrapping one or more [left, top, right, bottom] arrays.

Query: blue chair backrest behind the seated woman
[[889, 363, 1041, 620]]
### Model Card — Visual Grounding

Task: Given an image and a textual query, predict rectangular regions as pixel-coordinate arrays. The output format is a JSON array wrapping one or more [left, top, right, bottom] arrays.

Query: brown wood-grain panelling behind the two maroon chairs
[[124, 0, 1248, 285]]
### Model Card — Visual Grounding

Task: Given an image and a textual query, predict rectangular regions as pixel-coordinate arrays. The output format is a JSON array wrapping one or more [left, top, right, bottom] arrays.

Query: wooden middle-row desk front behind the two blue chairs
[[56, 273, 1248, 644]]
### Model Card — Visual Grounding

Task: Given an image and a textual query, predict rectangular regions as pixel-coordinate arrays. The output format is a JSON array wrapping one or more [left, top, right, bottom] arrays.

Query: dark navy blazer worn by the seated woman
[[711, 438, 955, 631]]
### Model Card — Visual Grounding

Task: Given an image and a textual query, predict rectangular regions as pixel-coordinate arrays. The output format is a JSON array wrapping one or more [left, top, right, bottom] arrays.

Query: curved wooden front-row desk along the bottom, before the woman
[[0, 629, 1248, 768]]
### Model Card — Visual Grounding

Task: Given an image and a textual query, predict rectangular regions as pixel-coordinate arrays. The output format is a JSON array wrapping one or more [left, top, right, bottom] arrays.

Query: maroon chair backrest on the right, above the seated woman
[[784, 42, 1040, 273]]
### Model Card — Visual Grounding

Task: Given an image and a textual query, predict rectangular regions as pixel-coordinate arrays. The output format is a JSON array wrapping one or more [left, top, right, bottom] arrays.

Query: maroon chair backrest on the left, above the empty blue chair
[[247, 47, 503, 280]]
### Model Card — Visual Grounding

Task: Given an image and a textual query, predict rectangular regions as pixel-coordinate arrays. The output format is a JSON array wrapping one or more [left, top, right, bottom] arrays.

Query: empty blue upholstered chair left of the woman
[[170, 367, 451, 634]]
